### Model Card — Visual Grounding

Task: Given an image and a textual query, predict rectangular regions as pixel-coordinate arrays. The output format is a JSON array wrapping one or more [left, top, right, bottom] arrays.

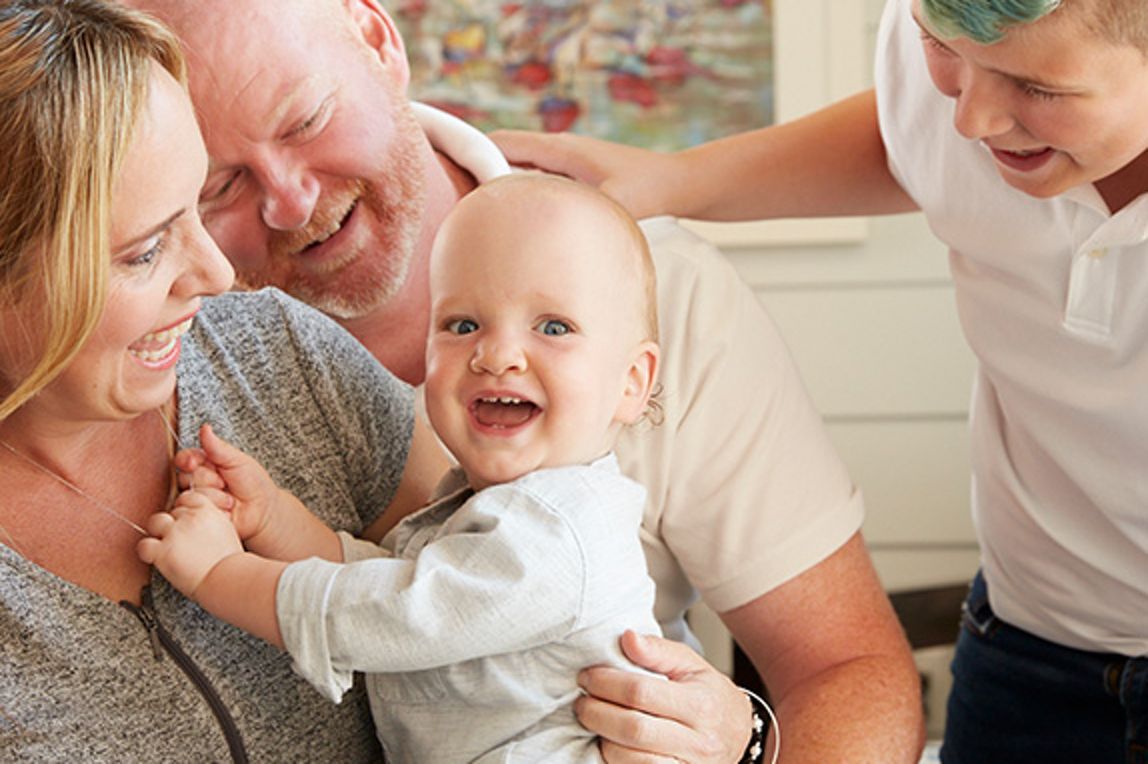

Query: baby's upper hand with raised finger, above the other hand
[[174, 424, 279, 541]]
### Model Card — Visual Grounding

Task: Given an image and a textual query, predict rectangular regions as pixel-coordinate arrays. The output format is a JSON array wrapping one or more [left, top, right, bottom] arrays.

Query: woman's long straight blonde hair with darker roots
[[0, 0, 185, 421]]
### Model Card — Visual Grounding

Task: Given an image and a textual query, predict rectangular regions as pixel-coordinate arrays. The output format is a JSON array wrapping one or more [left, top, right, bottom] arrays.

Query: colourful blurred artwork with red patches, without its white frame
[[388, 0, 774, 149]]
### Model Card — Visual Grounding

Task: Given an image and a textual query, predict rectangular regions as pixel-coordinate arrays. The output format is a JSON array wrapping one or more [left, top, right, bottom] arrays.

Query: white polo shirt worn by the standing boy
[[876, 0, 1148, 655]]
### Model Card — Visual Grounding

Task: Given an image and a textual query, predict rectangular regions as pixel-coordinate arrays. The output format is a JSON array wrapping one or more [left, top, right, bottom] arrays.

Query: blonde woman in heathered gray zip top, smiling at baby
[[0, 0, 443, 762]]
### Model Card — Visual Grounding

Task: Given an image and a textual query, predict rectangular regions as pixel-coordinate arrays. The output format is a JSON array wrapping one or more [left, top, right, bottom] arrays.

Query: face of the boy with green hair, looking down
[[913, 0, 1148, 198]]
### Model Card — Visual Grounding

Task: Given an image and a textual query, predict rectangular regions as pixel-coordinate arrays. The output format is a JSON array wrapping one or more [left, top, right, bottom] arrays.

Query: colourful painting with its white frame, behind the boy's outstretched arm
[[389, 0, 864, 247]]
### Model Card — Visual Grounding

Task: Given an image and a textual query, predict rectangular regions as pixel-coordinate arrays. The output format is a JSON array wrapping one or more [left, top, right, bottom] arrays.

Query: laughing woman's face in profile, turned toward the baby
[[13, 65, 234, 421]]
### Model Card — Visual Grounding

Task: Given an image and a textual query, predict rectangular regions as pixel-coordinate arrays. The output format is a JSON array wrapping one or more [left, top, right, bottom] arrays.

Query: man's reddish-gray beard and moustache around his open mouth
[[236, 103, 426, 319]]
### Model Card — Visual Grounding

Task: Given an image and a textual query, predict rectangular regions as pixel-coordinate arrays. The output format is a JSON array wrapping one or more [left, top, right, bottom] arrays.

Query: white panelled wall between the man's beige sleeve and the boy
[[696, 0, 978, 679]]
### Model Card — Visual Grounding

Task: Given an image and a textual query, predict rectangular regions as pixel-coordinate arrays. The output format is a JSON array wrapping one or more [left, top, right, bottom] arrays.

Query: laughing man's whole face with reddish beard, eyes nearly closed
[[165, 0, 432, 319]]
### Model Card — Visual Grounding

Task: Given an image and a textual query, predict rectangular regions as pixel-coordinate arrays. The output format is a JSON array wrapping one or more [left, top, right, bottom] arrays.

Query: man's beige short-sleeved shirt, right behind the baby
[[616, 218, 863, 639]]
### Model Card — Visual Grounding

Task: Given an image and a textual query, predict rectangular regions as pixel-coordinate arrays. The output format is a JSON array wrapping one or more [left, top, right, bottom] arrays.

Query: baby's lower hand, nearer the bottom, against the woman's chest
[[135, 491, 243, 598]]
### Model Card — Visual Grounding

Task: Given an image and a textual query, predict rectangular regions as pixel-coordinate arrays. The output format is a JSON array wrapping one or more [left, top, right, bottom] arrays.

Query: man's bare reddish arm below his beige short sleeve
[[722, 533, 924, 764]]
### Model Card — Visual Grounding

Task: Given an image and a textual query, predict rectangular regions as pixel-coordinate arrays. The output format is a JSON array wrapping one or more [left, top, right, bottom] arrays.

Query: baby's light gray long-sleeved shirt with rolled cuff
[[277, 454, 660, 764]]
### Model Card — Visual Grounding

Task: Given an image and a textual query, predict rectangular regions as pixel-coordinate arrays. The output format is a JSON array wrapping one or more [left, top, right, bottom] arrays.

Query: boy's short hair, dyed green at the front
[[921, 0, 1148, 55]]
